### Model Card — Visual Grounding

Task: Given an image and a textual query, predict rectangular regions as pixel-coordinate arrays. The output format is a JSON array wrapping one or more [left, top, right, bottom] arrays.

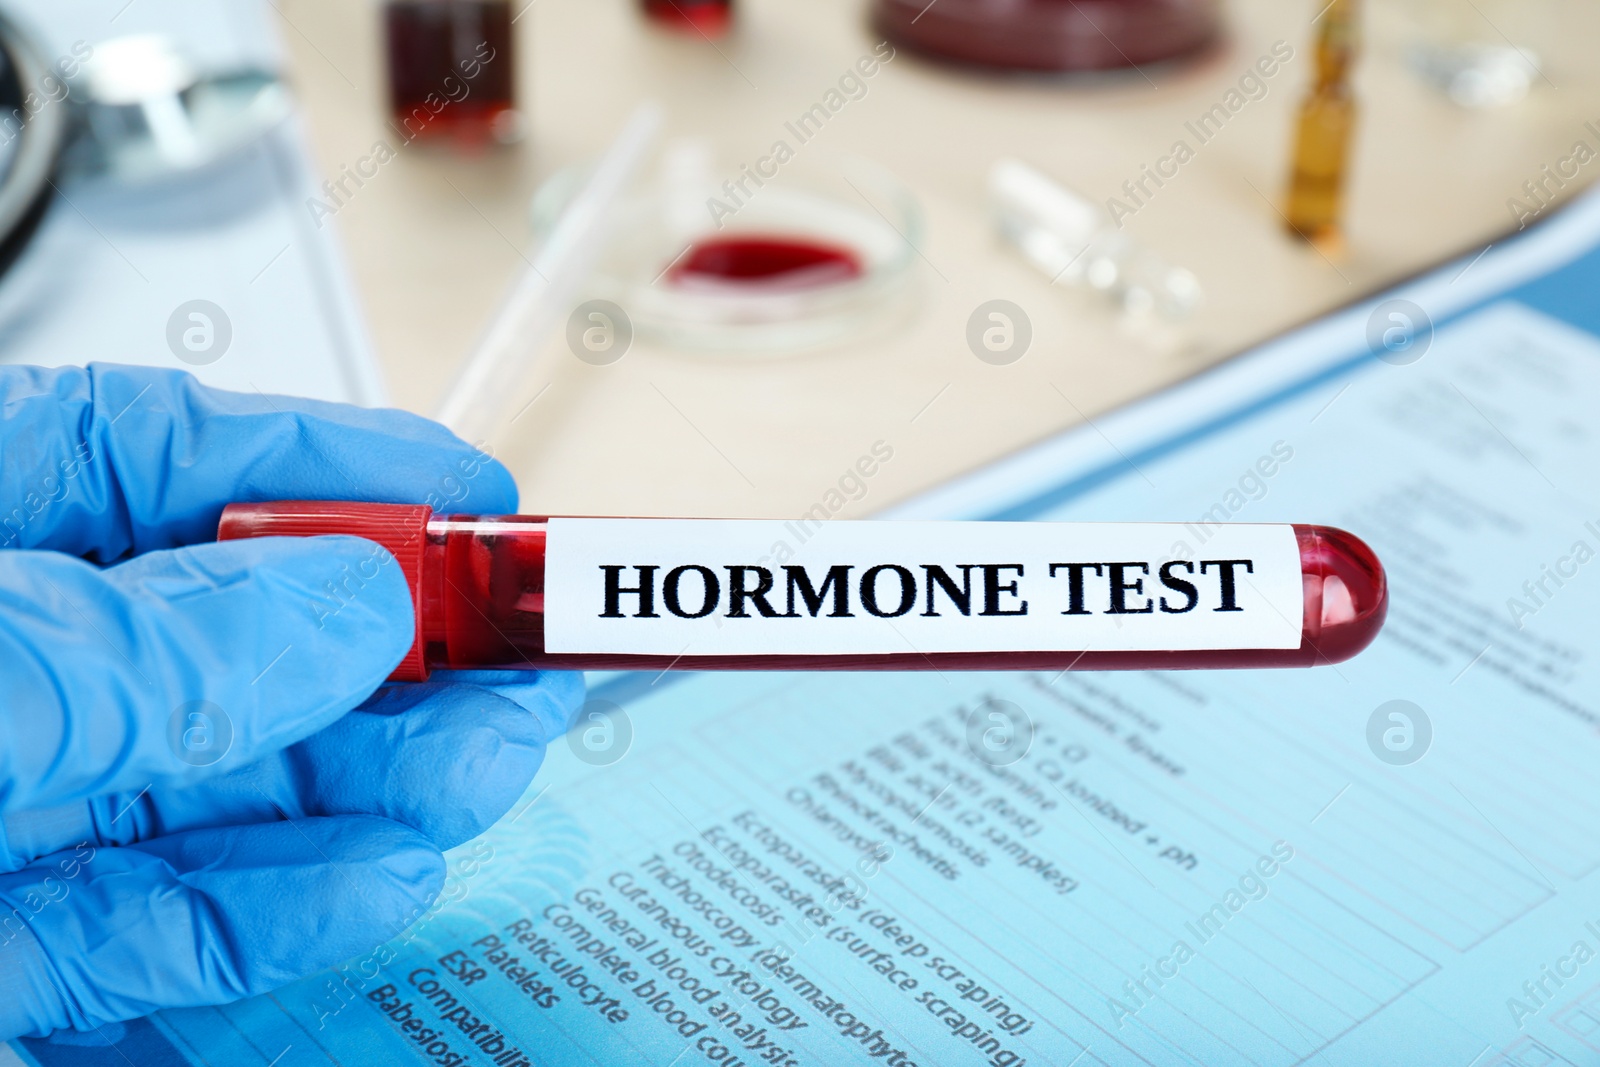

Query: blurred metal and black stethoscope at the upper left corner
[[0, 13, 291, 274]]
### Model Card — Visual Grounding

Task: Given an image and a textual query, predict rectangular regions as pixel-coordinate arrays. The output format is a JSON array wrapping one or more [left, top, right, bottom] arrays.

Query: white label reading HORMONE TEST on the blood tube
[[544, 518, 1302, 657]]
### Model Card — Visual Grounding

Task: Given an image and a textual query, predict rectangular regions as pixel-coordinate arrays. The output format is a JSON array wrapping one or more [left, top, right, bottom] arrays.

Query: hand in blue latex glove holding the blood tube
[[0, 366, 582, 1038]]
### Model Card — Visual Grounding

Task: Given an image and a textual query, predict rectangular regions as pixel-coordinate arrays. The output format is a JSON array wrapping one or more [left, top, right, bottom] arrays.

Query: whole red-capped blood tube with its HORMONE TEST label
[[218, 501, 1389, 680]]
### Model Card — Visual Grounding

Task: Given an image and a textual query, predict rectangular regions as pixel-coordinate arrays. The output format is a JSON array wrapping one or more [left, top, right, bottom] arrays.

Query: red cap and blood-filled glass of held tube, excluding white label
[[218, 501, 1389, 681]]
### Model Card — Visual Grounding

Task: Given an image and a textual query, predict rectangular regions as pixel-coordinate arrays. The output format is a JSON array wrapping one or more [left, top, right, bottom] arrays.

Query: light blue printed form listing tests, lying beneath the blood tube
[[18, 202, 1600, 1067]]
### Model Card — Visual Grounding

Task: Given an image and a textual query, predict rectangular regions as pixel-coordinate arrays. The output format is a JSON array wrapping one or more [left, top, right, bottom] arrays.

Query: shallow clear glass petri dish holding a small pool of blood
[[533, 141, 923, 358]]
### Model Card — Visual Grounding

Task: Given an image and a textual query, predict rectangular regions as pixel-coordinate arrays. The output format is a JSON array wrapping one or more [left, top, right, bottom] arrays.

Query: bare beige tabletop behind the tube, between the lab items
[[277, 0, 1600, 517]]
